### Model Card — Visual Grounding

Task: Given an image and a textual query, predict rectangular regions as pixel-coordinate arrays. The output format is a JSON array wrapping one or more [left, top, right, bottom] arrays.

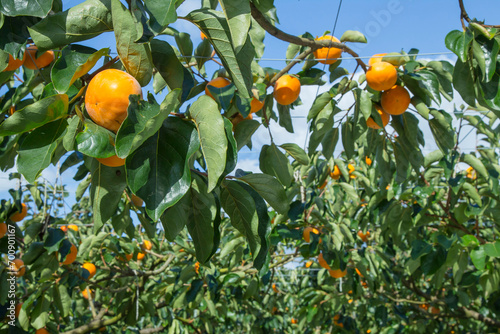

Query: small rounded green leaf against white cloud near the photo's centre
[[259, 143, 293, 187]]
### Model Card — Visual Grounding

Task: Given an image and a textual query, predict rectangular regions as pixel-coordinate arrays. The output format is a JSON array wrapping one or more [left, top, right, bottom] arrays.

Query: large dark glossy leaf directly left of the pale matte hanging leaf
[[126, 117, 200, 221]]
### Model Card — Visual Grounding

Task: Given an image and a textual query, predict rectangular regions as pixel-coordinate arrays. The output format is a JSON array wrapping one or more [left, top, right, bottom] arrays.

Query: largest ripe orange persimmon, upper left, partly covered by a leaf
[[85, 69, 142, 133]]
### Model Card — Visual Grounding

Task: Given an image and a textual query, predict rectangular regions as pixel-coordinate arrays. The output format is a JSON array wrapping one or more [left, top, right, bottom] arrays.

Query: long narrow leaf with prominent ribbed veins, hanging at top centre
[[186, 9, 255, 98]]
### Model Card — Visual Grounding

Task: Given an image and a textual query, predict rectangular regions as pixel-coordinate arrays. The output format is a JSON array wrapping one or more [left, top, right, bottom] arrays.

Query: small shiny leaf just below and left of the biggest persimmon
[[75, 120, 115, 158]]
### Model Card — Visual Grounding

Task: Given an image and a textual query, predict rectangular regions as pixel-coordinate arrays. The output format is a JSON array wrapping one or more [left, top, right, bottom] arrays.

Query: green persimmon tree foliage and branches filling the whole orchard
[[0, 0, 500, 333]]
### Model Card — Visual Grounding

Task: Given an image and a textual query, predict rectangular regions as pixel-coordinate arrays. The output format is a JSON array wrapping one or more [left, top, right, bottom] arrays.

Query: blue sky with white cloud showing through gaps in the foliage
[[0, 0, 500, 214]]
